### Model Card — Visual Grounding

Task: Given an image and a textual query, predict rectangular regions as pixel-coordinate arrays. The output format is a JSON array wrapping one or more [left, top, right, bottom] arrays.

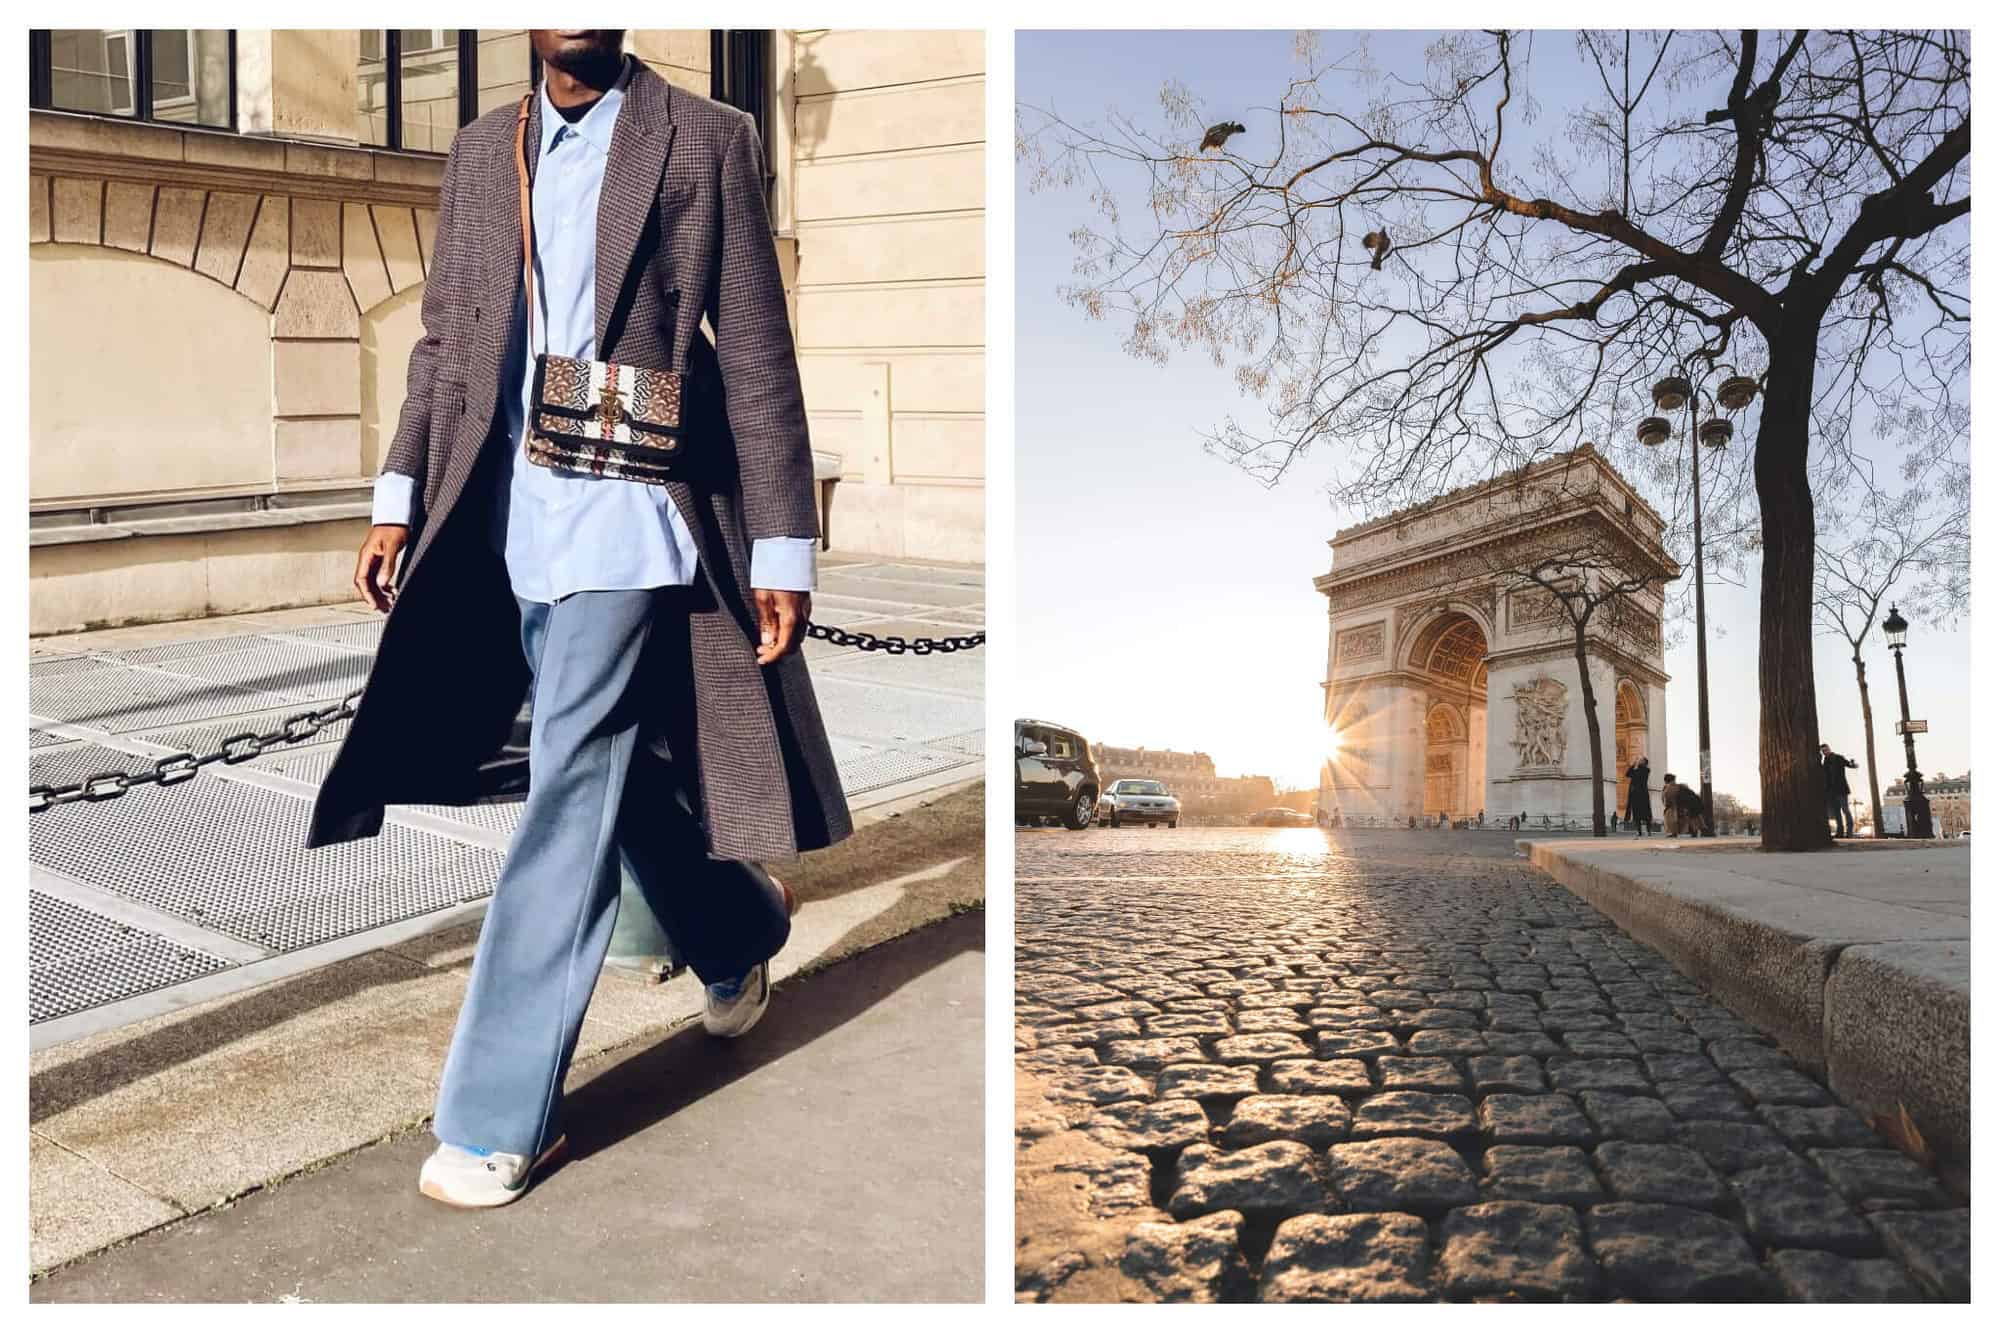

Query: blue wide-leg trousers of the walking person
[[436, 588, 792, 1155]]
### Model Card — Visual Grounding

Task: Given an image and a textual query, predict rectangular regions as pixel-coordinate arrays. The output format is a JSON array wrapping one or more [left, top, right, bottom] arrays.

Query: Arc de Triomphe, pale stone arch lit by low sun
[[1314, 444, 1686, 827]]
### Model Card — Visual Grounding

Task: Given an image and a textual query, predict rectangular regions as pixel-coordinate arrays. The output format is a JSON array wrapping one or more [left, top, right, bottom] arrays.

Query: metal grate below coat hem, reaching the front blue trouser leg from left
[[28, 779, 500, 951]]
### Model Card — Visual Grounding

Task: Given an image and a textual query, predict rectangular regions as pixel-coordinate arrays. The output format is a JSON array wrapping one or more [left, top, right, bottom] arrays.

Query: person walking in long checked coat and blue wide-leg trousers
[[308, 28, 852, 1207]]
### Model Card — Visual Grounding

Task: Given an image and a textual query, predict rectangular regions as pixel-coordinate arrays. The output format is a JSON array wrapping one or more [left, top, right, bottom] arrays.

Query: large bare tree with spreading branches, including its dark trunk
[[1020, 30, 1972, 849]]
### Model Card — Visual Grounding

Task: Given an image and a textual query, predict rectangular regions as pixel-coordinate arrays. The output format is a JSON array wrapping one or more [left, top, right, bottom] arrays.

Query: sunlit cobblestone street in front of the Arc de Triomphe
[[1016, 829, 1970, 1301]]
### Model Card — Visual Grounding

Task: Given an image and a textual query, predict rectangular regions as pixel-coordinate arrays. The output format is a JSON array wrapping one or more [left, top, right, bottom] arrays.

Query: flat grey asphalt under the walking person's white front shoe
[[30, 913, 984, 1301]]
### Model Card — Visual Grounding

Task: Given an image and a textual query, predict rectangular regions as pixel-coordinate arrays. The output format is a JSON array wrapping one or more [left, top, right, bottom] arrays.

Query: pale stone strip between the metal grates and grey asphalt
[[28, 783, 986, 1271]]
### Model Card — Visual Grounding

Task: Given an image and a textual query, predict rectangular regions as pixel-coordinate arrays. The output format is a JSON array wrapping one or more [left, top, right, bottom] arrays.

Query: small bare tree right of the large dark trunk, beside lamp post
[[1812, 486, 1972, 831]]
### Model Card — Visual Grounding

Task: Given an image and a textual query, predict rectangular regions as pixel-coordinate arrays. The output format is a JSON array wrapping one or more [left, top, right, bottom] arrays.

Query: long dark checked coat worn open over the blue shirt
[[306, 62, 850, 861]]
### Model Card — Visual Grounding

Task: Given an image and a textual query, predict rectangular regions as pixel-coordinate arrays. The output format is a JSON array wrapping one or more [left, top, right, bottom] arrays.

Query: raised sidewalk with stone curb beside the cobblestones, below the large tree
[[1520, 839, 1972, 1175]]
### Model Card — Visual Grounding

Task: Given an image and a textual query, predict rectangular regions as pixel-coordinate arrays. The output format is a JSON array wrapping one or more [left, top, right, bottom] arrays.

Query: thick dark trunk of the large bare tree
[[1756, 338, 1834, 851]]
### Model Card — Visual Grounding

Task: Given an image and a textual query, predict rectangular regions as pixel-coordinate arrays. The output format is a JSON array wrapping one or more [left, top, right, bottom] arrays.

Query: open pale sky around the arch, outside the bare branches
[[1014, 30, 1972, 805]]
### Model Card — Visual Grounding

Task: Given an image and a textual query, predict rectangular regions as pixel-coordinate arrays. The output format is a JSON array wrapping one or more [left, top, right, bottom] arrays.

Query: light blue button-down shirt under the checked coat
[[374, 67, 814, 602]]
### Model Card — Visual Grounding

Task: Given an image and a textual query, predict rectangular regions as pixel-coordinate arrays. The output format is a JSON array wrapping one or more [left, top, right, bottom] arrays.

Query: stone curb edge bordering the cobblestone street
[[1516, 839, 1972, 1175]]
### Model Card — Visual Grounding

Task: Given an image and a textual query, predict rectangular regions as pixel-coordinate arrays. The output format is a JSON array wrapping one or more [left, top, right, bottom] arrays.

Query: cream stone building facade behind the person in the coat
[[28, 30, 984, 632]]
